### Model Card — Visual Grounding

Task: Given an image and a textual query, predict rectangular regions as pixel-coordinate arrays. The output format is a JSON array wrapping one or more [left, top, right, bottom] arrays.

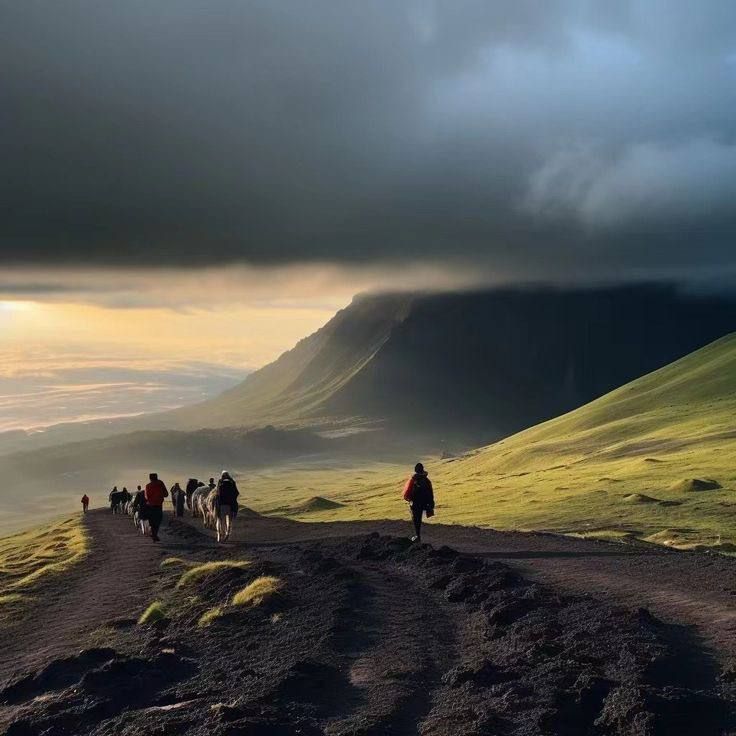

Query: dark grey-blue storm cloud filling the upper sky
[[0, 0, 736, 275]]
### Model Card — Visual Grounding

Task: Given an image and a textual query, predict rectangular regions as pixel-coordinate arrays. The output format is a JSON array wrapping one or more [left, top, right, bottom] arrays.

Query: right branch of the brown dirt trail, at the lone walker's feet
[[221, 514, 736, 660]]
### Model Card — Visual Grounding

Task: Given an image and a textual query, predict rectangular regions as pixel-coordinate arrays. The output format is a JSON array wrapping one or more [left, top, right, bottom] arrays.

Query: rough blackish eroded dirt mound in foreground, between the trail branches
[[0, 535, 736, 736]]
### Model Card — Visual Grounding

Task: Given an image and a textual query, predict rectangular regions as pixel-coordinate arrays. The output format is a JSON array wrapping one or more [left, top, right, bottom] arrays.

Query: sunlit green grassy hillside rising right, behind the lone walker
[[253, 334, 736, 546]]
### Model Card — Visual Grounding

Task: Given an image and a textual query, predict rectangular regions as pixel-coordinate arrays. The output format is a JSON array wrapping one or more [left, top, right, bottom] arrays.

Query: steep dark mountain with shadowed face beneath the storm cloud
[[173, 286, 736, 440]]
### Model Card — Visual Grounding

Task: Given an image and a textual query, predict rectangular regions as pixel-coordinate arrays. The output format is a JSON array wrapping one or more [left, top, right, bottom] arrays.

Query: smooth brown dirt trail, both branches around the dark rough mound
[[5, 511, 736, 683]]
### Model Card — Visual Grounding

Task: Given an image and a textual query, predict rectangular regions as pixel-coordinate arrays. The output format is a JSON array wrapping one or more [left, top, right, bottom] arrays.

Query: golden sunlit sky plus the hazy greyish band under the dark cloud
[[0, 264, 486, 431]]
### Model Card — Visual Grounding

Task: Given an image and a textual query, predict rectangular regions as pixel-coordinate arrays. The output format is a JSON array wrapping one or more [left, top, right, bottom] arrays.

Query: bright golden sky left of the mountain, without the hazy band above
[[0, 274, 342, 432]]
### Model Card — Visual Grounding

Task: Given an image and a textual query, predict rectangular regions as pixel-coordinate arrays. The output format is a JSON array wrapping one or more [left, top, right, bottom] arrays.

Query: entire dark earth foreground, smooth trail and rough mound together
[[0, 510, 736, 736]]
